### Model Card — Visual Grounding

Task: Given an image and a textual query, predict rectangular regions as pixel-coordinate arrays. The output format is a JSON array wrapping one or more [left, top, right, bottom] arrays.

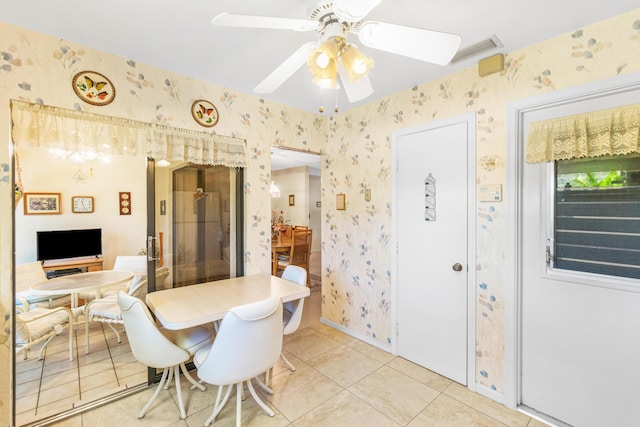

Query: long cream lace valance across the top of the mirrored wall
[[11, 100, 246, 167]]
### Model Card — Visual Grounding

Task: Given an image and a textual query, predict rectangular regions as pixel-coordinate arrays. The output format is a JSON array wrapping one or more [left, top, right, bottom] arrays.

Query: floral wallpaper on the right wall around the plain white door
[[322, 9, 640, 393]]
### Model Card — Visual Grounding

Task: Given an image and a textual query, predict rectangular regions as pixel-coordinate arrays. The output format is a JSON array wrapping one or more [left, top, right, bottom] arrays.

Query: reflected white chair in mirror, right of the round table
[[84, 276, 147, 354]]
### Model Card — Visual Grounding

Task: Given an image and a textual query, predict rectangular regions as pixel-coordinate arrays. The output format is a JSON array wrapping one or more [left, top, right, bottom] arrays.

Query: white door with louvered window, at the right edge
[[520, 86, 640, 427]]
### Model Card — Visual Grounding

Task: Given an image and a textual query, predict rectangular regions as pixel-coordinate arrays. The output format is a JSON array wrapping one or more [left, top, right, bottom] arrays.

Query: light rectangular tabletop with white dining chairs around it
[[146, 274, 310, 330]]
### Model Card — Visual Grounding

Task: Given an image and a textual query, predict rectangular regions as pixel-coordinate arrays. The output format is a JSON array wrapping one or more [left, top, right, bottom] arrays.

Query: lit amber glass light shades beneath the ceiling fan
[[307, 36, 373, 89]]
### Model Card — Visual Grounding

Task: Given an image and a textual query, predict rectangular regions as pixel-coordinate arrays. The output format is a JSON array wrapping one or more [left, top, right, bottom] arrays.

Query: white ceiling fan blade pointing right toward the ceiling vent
[[358, 21, 462, 65]]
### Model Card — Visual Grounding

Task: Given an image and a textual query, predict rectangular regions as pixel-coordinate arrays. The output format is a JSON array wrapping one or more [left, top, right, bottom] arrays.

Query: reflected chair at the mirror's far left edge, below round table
[[16, 297, 80, 360]]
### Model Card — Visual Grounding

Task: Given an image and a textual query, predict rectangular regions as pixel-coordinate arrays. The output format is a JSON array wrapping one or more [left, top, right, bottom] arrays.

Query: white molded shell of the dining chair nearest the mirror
[[118, 291, 190, 368]]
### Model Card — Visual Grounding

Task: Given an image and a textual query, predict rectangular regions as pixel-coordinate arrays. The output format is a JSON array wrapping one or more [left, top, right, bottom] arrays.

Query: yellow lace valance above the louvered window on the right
[[526, 104, 640, 163]]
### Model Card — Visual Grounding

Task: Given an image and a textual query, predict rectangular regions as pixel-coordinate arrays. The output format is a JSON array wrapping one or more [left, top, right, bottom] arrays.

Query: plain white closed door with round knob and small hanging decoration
[[395, 114, 475, 385]]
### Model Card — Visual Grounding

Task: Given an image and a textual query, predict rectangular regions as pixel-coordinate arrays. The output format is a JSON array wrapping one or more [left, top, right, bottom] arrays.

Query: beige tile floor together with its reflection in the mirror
[[18, 254, 545, 427]]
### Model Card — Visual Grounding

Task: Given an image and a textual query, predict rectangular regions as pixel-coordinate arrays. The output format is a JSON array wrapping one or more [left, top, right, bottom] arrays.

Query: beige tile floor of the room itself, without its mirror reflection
[[35, 290, 545, 427]]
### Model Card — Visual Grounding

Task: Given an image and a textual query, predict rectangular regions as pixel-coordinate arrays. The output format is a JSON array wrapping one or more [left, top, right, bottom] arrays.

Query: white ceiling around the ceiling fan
[[0, 0, 639, 114]]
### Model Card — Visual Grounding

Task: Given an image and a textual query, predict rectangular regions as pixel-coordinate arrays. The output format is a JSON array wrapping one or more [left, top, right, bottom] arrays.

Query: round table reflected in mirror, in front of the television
[[30, 270, 133, 308]]
